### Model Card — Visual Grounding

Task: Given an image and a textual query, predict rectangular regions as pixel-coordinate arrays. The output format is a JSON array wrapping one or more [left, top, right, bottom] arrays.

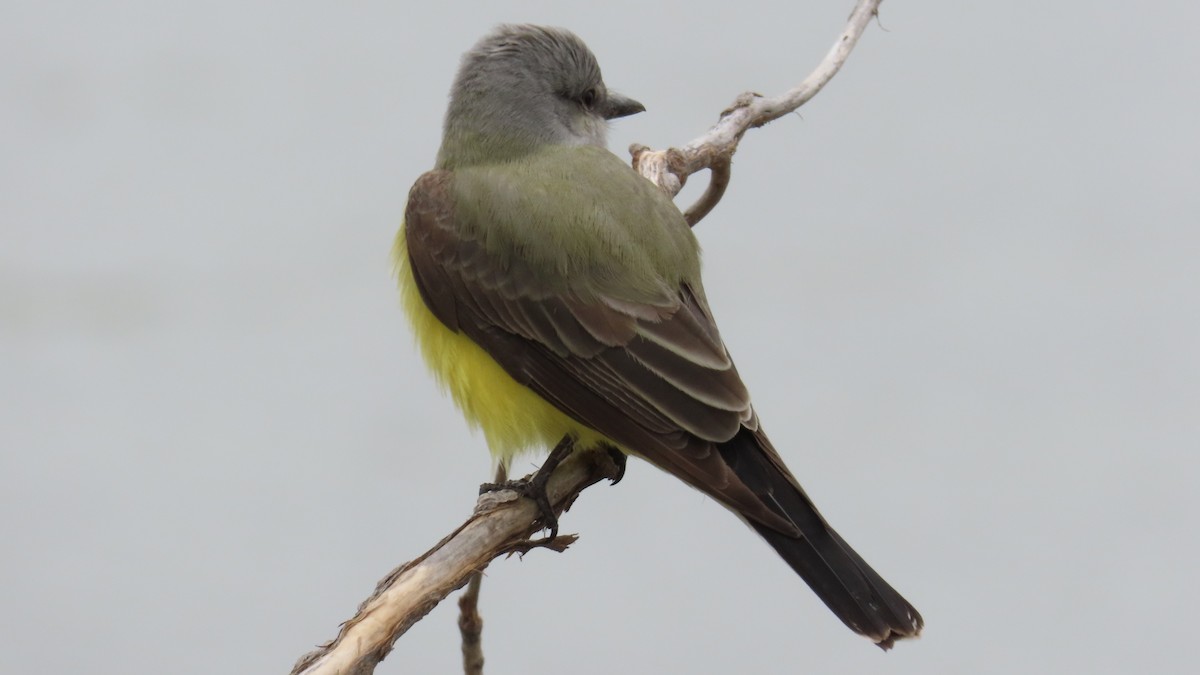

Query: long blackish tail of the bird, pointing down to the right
[[718, 428, 924, 650]]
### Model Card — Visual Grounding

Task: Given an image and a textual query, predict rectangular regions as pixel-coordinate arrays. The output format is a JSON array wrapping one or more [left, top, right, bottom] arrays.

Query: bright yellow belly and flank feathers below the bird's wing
[[392, 226, 616, 465]]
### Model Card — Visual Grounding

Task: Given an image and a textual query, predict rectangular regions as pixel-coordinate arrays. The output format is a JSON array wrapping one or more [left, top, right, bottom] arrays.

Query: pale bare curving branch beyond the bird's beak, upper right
[[629, 0, 883, 226]]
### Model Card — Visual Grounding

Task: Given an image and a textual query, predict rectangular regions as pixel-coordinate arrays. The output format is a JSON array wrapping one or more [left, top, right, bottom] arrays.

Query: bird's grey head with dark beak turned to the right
[[438, 25, 646, 168]]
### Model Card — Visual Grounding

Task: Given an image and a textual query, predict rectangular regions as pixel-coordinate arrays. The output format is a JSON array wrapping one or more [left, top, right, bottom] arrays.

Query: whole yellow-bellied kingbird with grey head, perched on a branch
[[395, 25, 923, 649]]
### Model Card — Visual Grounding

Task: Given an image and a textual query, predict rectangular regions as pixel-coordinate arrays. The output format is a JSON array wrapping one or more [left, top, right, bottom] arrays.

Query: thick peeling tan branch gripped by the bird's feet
[[292, 449, 618, 675]]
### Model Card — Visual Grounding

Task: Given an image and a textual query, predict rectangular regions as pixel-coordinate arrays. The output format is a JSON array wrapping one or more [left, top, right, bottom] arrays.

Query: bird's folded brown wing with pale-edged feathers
[[404, 168, 799, 537]]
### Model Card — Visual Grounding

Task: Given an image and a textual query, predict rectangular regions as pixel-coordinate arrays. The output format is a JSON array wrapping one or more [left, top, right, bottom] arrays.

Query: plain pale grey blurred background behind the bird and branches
[[0, 0, 1200, 674]]
